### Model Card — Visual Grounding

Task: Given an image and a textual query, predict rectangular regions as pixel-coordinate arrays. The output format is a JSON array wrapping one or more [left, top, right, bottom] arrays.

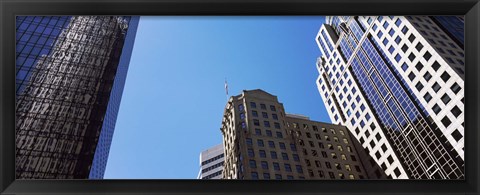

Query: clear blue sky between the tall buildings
[[105, 16, 330, 179]]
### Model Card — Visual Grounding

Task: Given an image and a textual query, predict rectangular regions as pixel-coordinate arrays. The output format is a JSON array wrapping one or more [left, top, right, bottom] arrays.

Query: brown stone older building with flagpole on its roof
[[221, 90, 386, 179]]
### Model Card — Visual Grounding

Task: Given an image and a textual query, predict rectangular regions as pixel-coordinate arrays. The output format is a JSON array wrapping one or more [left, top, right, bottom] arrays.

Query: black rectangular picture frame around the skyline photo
[[0, 0, 480, 195]]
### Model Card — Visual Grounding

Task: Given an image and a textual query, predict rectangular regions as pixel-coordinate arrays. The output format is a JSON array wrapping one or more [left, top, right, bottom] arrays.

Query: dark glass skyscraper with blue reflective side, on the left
[[16, 16, 138, 179]]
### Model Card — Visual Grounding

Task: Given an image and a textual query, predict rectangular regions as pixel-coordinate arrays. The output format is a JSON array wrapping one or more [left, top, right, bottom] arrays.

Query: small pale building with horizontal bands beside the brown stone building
[[197, 144, 224, 179]]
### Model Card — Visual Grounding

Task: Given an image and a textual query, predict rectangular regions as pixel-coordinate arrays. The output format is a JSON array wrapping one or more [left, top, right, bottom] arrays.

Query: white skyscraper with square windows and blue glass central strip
[[316, 16, 465, 179]]
